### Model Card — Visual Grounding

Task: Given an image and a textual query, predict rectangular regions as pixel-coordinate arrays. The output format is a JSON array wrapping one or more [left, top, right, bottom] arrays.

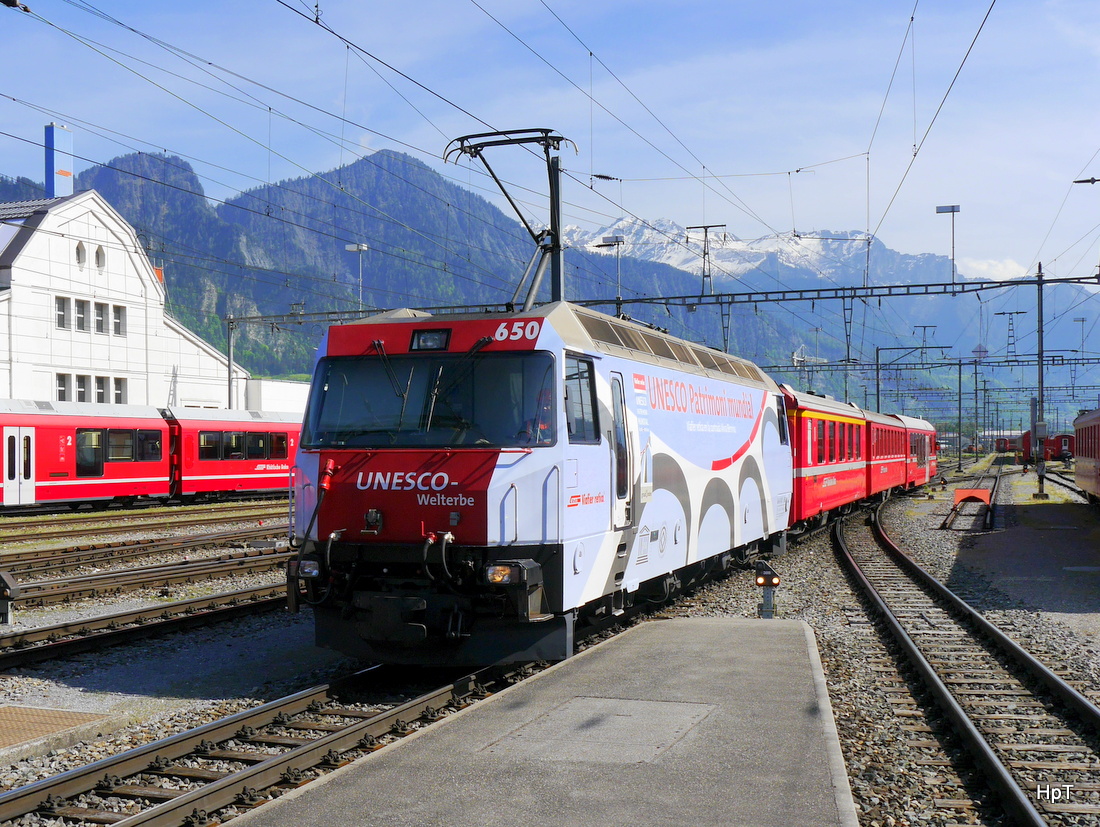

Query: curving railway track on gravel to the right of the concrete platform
[[835, 508, 1100, 825]]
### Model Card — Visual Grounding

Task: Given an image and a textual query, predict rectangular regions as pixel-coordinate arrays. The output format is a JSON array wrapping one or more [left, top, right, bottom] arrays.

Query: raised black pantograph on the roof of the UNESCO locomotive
[[443, 129, 572, 310]]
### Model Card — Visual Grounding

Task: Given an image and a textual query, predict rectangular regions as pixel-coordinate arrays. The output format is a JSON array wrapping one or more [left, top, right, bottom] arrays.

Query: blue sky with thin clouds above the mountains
[[0, 0, 1100, 285]]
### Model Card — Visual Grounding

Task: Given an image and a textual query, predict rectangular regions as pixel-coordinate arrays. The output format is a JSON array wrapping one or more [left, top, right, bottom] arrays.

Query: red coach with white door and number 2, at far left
[[0, 399, 169, 506]]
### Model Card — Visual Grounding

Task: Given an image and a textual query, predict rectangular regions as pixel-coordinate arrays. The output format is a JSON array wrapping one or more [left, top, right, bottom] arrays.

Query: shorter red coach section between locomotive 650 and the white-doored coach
[[162, 408, 301, 498]]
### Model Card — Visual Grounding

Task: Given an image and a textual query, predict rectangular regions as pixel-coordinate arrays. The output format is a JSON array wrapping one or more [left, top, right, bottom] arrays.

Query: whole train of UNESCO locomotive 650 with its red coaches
[[288, 302, 935, 664]]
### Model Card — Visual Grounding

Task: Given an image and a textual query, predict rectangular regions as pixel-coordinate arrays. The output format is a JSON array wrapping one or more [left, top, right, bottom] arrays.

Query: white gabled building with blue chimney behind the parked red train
[[0, 124, 307, 412]]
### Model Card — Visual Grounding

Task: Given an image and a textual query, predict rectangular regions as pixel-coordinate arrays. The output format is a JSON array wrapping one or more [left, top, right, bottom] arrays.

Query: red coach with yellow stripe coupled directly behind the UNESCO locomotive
[[781, 385, 868, 528]]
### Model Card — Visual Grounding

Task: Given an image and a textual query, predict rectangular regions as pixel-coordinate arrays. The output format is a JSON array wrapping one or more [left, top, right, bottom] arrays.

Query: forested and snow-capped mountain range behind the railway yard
[[0, 151, 1081, 433]]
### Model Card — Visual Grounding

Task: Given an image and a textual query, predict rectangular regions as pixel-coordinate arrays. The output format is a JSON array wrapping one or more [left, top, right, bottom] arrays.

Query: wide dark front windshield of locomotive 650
[[301, 352, 556, 448]]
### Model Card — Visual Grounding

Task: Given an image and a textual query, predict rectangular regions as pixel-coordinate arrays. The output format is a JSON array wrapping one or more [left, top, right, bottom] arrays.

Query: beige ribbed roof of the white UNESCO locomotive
[[351, 301, 779, 392]]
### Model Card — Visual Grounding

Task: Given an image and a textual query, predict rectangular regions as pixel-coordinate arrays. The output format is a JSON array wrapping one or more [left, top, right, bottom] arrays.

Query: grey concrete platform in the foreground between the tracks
[[233, 618, 858, 827]]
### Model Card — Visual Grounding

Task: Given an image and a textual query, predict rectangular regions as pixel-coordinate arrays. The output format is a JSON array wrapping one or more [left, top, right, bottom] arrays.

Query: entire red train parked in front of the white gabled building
[[0, 399, 300, 507]]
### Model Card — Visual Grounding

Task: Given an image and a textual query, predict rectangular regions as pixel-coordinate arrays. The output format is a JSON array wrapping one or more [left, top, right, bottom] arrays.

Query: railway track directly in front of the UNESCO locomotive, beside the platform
[[0, 666, 518, 827]]
